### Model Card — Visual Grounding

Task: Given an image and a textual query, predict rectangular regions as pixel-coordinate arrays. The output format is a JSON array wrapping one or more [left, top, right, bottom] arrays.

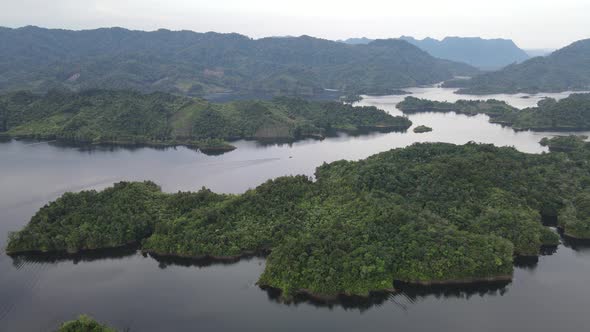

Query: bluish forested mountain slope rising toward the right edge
[[444, 39, 590, 94]]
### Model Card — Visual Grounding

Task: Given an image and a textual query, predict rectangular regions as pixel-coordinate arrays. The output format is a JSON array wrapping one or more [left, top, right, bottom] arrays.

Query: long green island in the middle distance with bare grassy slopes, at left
[[0, 90, 411, 152]]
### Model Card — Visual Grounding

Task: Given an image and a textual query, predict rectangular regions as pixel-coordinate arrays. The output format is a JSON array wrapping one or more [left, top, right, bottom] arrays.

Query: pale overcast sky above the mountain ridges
[[0, 0, 590, 48]]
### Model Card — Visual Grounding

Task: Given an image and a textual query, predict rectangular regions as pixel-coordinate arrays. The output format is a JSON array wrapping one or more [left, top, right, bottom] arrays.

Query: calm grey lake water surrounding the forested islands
[[0, 88, 590, 331]]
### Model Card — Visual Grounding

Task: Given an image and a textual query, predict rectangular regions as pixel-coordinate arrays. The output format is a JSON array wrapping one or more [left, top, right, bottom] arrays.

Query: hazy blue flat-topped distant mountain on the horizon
[[400, 36, 529, 70]]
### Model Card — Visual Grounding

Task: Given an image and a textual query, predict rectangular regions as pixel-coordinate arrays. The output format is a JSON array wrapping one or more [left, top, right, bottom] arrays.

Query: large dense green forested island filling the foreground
[[6, 143, 590, 299]]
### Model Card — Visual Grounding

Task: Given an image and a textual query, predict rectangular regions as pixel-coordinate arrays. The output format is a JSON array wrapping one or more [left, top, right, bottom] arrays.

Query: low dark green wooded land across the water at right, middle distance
[[397, 93, 590, 131]]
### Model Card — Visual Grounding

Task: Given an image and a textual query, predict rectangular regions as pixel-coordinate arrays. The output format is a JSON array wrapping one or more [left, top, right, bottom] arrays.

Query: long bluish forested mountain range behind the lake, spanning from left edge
[[0, 26, 474, 95]]
